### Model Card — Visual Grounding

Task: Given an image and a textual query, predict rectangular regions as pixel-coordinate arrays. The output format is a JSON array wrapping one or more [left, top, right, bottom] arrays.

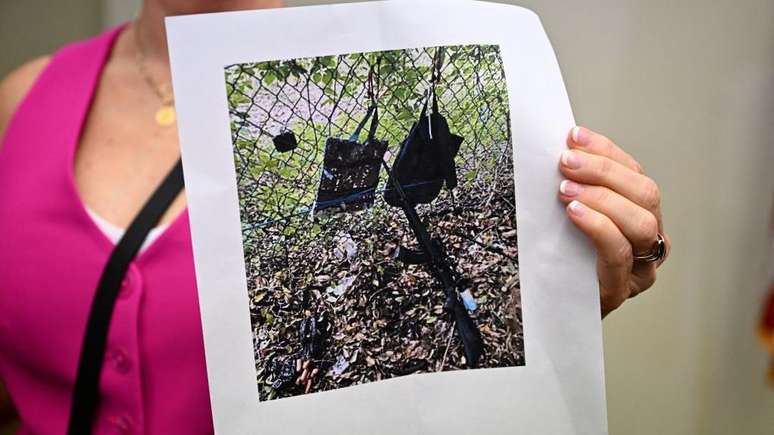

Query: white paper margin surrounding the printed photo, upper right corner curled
[[167, 0, 607, 435]]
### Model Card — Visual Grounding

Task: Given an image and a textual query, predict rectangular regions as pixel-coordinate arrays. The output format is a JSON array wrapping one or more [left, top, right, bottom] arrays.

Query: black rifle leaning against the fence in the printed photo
[[382, 160, 484, 368]]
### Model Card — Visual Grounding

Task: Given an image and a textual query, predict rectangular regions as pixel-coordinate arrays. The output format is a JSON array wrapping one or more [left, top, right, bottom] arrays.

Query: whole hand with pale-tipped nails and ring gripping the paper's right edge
[[560, 127, 671, 316]]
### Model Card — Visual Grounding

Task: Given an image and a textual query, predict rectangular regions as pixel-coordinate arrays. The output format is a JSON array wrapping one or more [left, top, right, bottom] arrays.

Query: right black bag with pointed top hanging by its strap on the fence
[[384, 50, 464, 207]]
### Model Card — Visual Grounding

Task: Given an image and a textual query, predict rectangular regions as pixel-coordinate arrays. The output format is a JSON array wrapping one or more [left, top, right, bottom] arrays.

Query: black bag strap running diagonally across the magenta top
[[67, 160, 183, 435]]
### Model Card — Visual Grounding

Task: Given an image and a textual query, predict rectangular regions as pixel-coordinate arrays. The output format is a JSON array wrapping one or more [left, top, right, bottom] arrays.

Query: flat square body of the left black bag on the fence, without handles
[[314, 138, 387, 213]]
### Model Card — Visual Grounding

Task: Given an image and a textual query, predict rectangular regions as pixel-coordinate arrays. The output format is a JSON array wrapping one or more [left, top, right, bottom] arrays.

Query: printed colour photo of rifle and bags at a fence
[[225, 45, 526, 401]]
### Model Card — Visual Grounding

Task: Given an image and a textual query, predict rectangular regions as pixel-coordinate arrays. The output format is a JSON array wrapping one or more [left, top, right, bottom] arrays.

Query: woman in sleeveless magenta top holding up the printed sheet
[[0, 0, 669, 433]]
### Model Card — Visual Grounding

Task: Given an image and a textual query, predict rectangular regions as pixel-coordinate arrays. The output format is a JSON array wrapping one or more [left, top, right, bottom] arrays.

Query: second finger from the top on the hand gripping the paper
[[559, 150, 661, 221]]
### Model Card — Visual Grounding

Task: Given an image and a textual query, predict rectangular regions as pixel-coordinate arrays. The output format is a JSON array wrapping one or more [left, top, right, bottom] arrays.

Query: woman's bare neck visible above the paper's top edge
[[132, 0, 285, 65]]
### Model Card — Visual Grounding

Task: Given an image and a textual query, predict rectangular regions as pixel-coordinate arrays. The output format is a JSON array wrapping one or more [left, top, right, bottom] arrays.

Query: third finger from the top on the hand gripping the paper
[[559, 180, 659, 254]]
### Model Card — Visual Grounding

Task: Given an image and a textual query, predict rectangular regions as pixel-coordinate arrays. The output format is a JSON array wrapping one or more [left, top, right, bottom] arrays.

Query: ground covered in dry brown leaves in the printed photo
[[246, 153, 525, 400]]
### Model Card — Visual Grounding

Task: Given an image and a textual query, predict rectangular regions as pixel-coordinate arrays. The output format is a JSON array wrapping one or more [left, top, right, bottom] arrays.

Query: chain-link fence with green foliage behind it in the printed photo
[[226, 46, 511, 258]]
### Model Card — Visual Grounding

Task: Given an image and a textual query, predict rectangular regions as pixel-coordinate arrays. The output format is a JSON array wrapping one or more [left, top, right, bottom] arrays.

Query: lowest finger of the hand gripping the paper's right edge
[[567, 201, 633, 314]]
